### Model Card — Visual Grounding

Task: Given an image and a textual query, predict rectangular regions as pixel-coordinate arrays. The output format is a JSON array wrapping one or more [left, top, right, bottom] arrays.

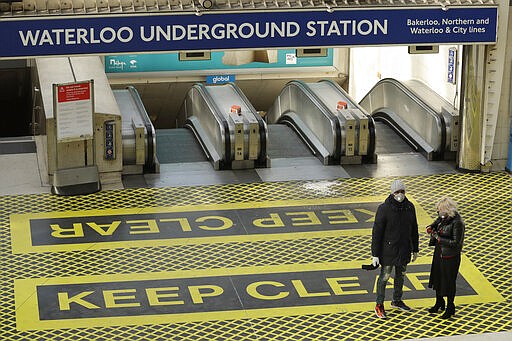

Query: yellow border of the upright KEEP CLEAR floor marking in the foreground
[[14, 256, 504, 330]]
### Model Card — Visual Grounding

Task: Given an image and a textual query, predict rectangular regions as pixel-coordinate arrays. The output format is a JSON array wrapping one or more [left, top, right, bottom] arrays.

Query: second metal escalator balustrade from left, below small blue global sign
[[178, 83, 268, 170]]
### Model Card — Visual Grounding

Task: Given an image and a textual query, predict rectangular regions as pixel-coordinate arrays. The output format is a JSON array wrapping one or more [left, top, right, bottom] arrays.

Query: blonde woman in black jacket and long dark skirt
[[427, 197, 465, 319]]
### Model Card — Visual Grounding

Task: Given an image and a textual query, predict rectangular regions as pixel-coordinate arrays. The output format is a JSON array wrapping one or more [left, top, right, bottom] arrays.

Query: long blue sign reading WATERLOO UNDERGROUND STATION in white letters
[[0, 6, 498, 58]]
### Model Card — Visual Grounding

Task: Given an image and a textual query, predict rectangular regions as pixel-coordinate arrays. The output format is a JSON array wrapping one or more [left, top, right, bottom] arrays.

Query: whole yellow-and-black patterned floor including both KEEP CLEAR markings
[[0, 172, 512, 340]]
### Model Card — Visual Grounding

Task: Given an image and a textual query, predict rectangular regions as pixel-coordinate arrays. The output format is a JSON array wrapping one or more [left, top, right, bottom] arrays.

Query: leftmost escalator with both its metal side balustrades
[[113, 84, 268, 175]]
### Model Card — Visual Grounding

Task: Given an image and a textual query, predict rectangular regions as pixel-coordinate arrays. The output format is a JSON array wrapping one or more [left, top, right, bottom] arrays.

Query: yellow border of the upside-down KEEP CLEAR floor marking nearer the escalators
[[10, 196, 431, 253]]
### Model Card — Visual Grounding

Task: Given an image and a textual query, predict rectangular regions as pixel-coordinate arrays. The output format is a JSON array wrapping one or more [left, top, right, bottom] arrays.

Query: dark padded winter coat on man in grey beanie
[[372, 194, 419, 265]]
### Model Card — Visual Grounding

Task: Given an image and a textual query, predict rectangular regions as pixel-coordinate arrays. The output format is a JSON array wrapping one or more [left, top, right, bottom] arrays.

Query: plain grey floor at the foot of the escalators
[[123, 123, 457, 187]]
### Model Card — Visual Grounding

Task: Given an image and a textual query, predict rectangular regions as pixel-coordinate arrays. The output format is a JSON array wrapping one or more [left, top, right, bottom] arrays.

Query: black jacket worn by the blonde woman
[[429, 213, 465, 258]]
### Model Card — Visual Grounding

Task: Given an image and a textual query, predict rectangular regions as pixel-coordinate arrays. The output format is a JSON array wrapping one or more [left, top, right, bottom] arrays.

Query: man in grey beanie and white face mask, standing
[[372, 180, 419, 318]]
